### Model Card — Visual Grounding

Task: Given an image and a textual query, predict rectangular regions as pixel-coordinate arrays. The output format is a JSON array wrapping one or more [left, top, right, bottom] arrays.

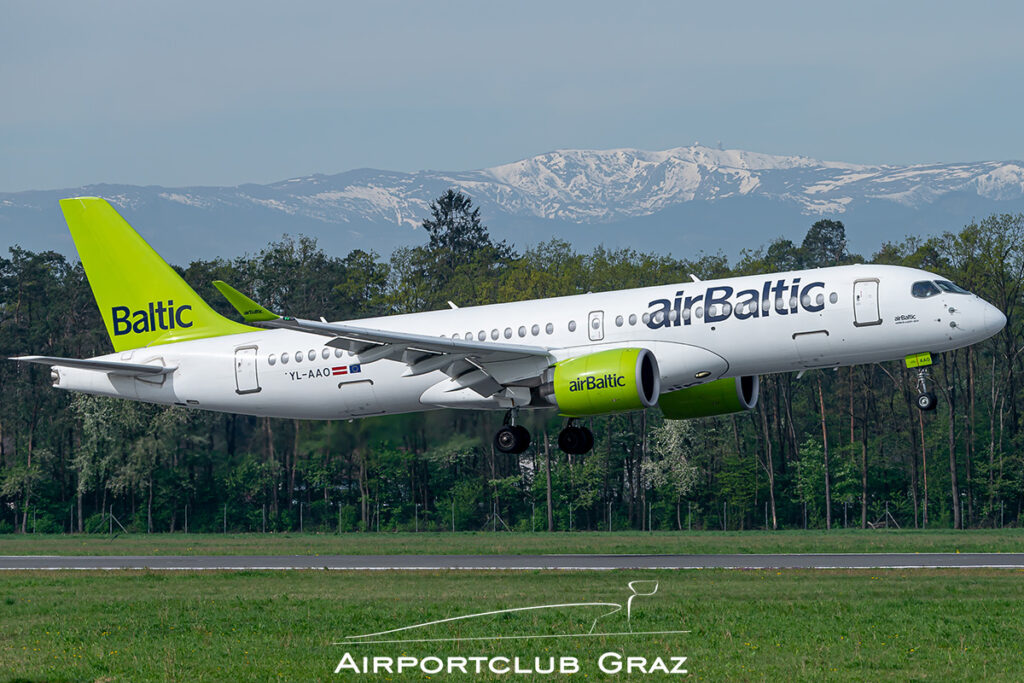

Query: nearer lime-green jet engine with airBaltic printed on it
[[549, 348, 662, 418]]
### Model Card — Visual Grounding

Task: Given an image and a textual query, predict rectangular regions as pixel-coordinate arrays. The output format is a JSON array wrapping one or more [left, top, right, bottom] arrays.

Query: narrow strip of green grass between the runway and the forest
[[0, 528, 1024, 555]]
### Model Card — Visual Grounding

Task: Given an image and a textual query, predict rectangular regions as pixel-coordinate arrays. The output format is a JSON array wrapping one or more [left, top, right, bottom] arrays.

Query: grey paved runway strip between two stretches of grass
[[0, 553, 1024, 570]]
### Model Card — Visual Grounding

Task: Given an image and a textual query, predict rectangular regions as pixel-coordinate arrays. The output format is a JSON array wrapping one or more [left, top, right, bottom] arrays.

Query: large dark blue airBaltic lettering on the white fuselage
[[646, 278, 825, 330]]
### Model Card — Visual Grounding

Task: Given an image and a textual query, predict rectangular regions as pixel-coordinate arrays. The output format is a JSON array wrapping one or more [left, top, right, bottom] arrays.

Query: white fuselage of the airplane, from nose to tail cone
[[54, 265, 1006, 420]]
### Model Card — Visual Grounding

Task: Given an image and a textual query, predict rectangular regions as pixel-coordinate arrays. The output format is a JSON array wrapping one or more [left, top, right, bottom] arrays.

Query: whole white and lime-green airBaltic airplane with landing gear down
[[12, 197, 1007, 455]]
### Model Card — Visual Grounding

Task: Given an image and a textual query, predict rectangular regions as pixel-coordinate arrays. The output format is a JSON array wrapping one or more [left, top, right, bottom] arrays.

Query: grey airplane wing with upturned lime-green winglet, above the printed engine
[[214, 281, 554, 397]]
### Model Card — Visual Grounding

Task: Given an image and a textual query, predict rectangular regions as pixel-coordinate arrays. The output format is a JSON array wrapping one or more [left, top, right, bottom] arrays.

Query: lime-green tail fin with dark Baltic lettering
[[60, 197, 255, 351]]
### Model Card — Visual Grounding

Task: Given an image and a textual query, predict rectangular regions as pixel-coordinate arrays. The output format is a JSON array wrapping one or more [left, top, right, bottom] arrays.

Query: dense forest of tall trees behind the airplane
[[0, 191, 1024, 533]]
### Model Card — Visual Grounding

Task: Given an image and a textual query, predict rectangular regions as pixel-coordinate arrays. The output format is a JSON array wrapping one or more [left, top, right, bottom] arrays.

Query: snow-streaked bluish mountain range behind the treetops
[[0, 144, 1024, 262]]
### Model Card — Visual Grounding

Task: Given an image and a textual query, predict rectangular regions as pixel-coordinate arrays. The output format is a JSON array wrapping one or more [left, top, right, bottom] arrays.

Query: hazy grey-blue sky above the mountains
[[0, 0, 1024, 191]]
